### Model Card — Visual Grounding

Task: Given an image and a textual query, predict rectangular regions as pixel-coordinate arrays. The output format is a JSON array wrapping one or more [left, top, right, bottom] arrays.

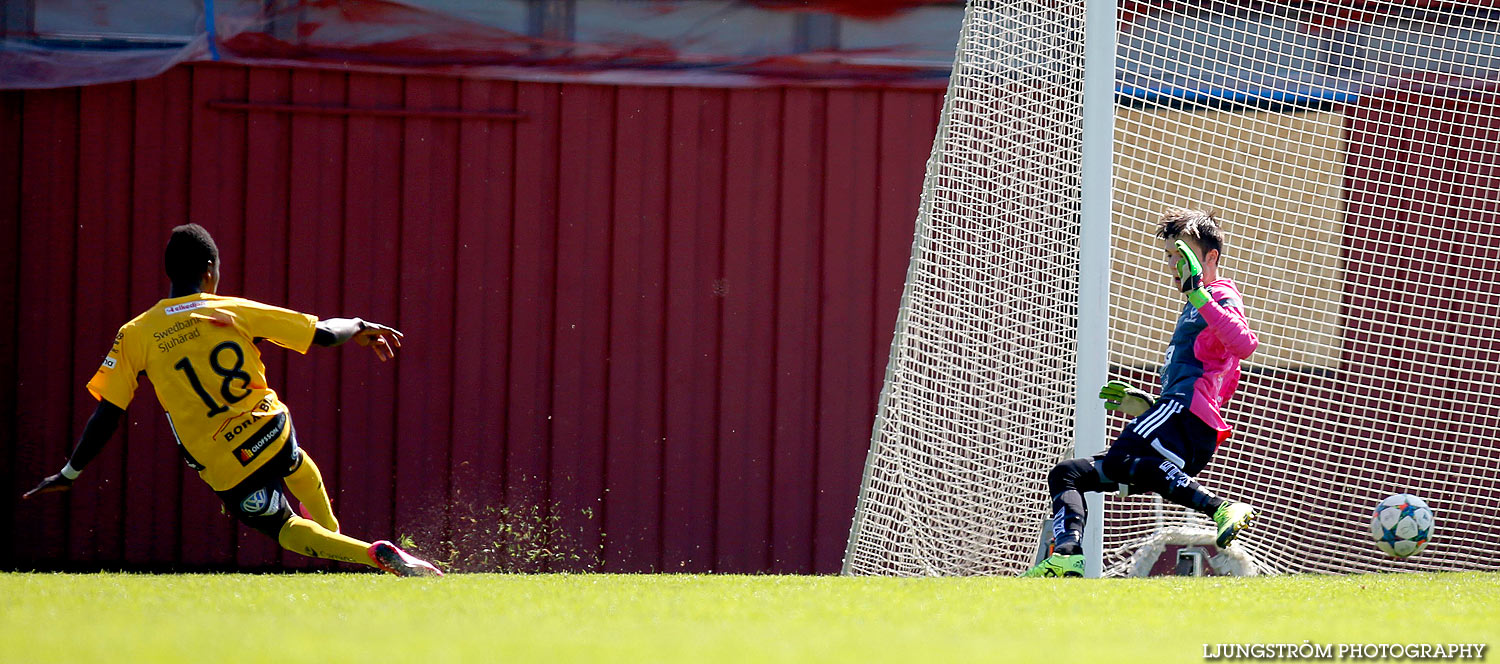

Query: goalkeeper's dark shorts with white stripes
[[1094, 399, 1218, 481]]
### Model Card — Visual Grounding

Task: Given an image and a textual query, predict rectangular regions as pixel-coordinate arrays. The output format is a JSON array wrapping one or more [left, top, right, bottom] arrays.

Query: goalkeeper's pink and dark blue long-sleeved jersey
[[1161, 279, 1260, 442]]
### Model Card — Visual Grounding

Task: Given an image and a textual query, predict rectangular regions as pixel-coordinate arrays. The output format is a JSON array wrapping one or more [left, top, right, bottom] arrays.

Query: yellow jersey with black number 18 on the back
[[89, 292, 318, 492]]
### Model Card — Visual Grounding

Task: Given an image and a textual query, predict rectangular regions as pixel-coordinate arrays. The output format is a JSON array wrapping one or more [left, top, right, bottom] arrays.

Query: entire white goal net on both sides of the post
[[845, 0, 1500, 574]]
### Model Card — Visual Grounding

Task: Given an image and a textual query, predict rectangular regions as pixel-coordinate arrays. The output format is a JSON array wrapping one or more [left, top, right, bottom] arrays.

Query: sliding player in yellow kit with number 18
[[23, 223, 443, 576]]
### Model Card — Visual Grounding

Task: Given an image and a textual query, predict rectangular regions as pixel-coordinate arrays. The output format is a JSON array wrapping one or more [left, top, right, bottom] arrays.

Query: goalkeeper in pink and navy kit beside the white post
[[1023, 210, 1259, 577]]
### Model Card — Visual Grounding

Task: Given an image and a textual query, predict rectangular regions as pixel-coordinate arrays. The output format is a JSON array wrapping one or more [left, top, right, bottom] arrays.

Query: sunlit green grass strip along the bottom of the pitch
[[0, 573, 1500, 664]]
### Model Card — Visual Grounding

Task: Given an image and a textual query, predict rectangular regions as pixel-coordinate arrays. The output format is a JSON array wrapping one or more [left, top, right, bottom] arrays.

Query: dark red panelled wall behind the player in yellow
[[0, 64, 942, 573]]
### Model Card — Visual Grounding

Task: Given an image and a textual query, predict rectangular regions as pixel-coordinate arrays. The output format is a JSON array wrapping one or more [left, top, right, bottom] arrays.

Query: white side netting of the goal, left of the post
[[846, 0, 1083, 574]]
